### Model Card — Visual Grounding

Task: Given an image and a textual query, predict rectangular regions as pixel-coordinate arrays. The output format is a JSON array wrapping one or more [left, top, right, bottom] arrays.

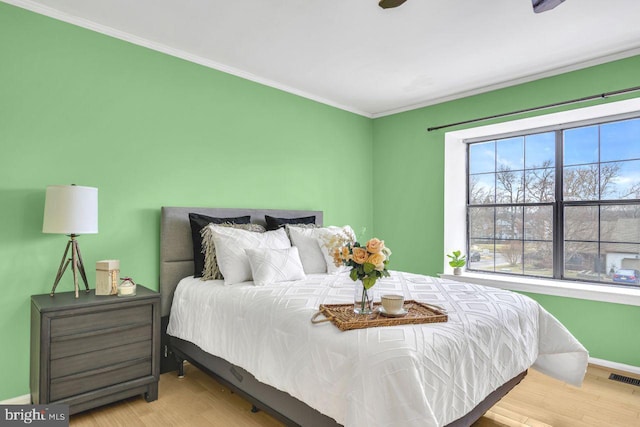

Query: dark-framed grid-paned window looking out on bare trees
[[466, 118, 640, 286]]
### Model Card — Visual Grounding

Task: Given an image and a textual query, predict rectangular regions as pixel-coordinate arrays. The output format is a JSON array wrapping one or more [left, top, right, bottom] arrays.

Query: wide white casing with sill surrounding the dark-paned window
[[441, 98, 640, 306]]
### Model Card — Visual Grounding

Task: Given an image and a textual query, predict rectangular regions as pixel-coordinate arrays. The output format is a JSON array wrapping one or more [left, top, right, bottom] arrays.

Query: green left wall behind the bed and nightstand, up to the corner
[[0, 3, 373, 400]]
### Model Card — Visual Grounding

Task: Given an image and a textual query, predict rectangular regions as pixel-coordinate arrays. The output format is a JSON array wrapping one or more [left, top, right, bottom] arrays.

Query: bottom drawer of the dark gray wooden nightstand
[[49, 357, 151, 401]]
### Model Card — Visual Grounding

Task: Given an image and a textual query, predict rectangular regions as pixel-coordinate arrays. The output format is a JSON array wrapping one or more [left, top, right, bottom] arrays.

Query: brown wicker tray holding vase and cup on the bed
[[311, 300, 449, 331]]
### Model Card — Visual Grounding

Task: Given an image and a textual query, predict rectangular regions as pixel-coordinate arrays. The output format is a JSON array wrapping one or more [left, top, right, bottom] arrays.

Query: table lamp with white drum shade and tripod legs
[[42, 185, 98, 298]]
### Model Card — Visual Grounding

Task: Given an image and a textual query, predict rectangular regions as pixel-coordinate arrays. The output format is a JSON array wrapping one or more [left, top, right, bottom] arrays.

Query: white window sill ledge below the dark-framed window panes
[[440, 272, 640, 306]]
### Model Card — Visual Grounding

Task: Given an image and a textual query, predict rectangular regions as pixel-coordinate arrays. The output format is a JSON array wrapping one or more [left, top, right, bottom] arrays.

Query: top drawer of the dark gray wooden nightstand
[[51, 304, 152, 338]]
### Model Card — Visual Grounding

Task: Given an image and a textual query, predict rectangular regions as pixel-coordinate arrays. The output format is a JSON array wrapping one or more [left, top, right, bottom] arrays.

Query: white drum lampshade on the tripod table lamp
[[42, 185, 98, 234]]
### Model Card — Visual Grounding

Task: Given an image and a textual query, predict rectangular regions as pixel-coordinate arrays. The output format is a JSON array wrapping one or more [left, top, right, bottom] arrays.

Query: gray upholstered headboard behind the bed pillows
[[160, 207, 322, 316]]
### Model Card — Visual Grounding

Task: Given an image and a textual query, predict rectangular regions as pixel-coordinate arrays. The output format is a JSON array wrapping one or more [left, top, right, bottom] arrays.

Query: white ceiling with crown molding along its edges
[[3, 0, 640, 117]]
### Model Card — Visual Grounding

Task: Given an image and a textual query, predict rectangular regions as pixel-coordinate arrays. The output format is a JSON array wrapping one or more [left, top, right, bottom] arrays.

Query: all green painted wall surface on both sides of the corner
[[0, 3, 640, 400]]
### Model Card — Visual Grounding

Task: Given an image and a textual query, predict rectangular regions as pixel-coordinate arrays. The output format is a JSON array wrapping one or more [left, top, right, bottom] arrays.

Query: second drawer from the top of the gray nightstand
[[50, 322, 153, 361]]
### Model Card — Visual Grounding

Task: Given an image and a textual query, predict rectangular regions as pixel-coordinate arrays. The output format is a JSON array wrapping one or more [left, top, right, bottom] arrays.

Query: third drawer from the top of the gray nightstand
[[51, 337, 151, 379]]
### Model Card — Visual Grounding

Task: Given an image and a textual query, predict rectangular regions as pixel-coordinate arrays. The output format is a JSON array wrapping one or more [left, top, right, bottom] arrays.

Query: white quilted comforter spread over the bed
[[168, 271, 588, 427]]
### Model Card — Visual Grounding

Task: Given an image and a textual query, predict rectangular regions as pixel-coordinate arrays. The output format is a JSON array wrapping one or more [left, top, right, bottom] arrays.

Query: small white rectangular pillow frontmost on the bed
[[245, 246, 305, 286]]
